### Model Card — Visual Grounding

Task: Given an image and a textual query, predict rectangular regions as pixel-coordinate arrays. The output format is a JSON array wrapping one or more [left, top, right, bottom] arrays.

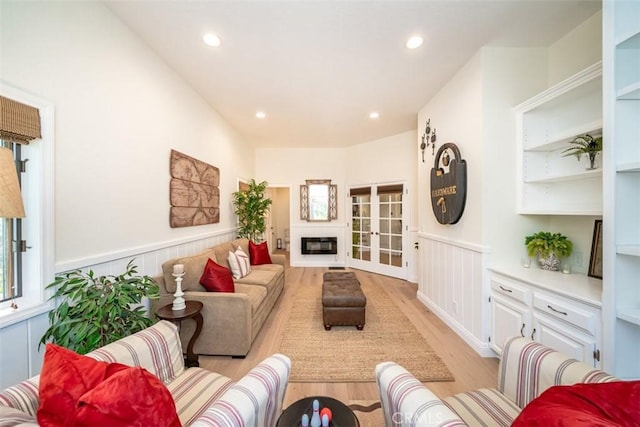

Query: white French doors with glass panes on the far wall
[[348, 184, 408, 279]]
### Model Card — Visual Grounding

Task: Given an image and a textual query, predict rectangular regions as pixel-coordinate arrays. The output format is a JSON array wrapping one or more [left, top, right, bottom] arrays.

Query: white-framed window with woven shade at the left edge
[[0, 86, 55, 328]]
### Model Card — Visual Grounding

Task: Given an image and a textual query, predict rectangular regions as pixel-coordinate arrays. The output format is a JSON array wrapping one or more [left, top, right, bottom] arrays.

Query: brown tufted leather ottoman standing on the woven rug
[[322, 272, 367, 331]]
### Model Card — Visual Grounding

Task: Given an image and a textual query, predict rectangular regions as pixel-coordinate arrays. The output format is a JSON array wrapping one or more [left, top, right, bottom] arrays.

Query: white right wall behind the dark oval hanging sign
[[418, 14, 601, 355]]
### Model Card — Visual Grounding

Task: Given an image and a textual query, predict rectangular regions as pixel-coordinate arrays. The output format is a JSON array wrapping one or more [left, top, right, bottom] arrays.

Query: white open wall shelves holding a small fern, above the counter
[[515, 63, 602, 215]]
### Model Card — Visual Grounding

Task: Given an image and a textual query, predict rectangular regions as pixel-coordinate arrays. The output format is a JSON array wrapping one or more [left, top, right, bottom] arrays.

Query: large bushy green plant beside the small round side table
[[40, 260, 159, 354]]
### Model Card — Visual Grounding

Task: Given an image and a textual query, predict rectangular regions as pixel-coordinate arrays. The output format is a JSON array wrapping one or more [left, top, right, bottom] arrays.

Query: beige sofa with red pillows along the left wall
[[151, 239, 285, 356]]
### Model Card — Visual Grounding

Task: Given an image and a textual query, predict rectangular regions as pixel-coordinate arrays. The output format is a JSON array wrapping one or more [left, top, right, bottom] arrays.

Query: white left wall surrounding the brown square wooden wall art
[[0, 1, 254, 389]]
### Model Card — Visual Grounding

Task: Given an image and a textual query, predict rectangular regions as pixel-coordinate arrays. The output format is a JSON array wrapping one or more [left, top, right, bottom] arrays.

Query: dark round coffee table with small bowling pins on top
[[276, 396, 360, 427]]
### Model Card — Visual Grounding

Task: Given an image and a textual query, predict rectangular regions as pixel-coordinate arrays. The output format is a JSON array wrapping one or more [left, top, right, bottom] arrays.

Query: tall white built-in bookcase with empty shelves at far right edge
[[602, 0, 640, 378]]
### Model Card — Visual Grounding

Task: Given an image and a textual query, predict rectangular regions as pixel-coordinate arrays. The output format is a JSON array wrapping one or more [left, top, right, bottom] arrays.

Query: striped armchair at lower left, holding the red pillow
[[0, 320, 291, 427]]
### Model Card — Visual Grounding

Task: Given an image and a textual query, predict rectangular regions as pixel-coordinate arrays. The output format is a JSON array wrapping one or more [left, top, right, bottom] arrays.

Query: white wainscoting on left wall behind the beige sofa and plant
[[0, 228, 236, 390]]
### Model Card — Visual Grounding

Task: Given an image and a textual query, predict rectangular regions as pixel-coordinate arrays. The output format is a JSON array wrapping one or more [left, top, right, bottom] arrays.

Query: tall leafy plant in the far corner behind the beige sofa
[[232, 179, 271, 242]]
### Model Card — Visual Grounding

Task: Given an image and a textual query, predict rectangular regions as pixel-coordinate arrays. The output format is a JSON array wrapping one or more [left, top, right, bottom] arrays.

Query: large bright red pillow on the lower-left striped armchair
[[37, 344, 180, 427]]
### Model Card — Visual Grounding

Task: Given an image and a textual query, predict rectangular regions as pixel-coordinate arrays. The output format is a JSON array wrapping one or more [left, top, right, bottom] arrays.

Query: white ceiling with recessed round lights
[[106, 0, 601, 147]]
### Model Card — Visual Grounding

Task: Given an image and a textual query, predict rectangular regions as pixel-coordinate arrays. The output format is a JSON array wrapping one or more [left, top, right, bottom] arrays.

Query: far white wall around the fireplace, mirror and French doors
[[255, 131, 418, 272]]
